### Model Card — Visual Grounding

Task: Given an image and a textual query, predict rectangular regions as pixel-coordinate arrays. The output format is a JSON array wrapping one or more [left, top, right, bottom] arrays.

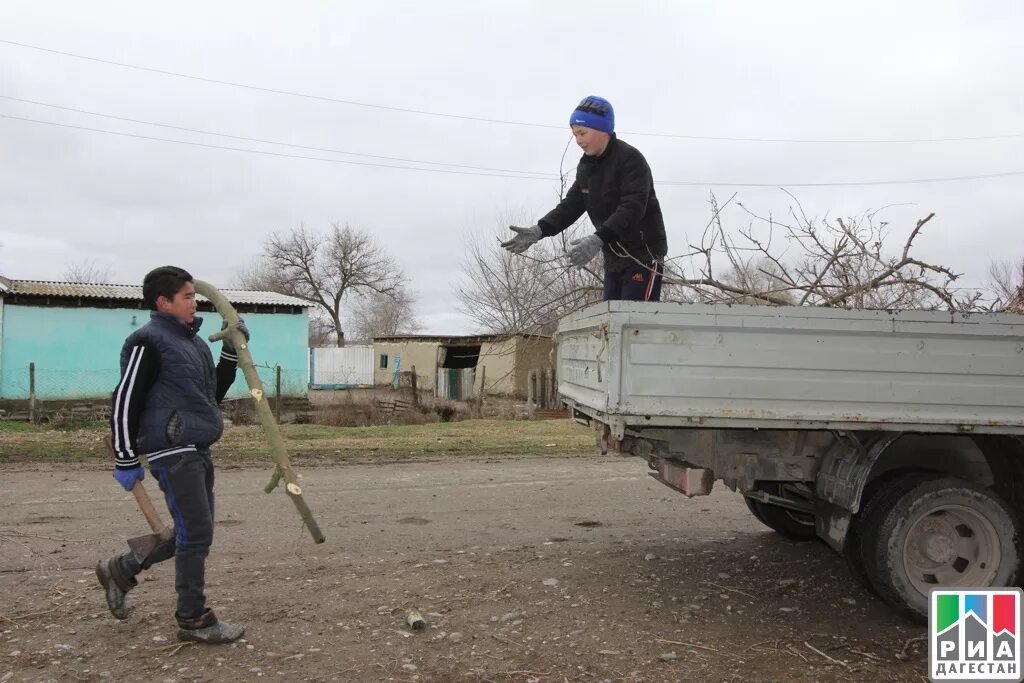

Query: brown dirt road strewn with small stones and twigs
[[0, 456, 927, 683]]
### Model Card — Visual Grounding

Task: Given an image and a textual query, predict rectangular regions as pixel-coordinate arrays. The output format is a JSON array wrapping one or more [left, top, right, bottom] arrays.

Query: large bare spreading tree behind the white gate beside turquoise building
[[238, 223, 408, 346]]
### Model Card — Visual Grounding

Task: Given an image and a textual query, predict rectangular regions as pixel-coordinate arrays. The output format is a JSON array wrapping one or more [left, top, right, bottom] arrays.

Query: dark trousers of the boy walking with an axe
[[120, 453, 213, 618]]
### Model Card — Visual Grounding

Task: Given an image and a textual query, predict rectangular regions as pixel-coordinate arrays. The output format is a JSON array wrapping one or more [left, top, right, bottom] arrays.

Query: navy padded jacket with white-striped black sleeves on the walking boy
[[111, 311, 238, 469]]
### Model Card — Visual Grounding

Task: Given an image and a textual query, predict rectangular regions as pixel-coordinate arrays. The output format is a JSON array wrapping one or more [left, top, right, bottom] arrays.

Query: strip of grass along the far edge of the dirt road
[[0, 420, 594, 464]]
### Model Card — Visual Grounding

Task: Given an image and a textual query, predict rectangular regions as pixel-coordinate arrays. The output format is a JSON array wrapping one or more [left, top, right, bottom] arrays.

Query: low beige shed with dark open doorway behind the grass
[[374, 335, 554, 400]]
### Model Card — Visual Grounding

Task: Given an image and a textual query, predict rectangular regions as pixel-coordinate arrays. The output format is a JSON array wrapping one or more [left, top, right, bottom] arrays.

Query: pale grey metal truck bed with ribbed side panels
[[557, 301, 1024, 437]]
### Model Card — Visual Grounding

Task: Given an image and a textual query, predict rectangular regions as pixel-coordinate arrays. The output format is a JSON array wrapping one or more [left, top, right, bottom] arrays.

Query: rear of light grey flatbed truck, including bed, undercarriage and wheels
[[556, 301, 1024, 617]]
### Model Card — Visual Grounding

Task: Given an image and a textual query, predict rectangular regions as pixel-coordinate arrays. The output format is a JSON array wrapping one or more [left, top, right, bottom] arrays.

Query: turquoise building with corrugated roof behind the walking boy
[[0, 278, 309, 400]]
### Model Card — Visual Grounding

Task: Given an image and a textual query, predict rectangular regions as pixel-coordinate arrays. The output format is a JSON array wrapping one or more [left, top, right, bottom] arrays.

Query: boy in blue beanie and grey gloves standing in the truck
[[502, 95, 669, 301]]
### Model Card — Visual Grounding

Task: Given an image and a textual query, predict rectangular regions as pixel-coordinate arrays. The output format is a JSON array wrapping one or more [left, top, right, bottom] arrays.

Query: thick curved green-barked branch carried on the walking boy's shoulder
[[195, 280, 324, 543]]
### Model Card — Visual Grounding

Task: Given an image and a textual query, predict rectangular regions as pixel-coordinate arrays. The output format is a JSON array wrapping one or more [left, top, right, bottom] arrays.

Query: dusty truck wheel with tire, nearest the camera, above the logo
[[861, 477, 1021, 621]]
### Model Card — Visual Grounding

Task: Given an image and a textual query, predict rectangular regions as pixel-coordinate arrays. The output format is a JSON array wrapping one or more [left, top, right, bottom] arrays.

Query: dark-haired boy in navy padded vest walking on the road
[[96, 266, 249, 643]]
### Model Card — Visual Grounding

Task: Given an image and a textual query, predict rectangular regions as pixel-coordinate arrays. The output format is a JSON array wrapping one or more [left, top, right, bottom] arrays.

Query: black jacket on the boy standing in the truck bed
[[537, 134, 669, 272]]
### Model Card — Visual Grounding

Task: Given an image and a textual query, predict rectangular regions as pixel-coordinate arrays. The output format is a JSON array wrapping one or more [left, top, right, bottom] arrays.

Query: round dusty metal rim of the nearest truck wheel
[[903, 505, 1002, 595]]
